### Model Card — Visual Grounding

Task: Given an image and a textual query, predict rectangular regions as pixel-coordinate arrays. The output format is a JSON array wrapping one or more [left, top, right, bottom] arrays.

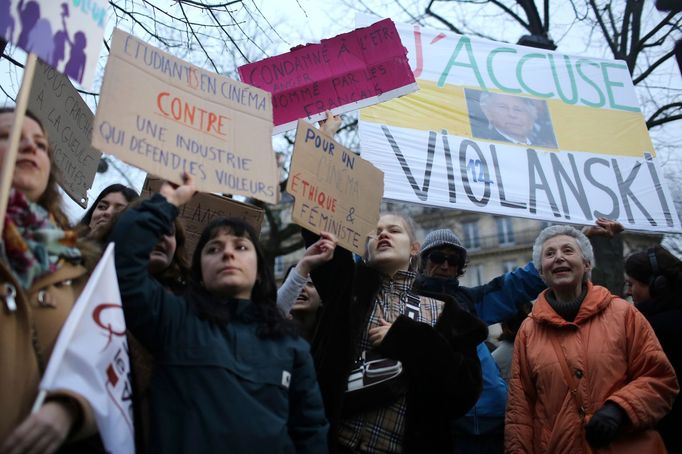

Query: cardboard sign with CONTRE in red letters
[[92, 30, 279, 203]]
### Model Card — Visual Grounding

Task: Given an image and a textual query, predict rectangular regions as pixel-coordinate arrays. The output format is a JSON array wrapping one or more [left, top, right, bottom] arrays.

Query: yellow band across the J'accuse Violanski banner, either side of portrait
[[360, 80, 655, 157]]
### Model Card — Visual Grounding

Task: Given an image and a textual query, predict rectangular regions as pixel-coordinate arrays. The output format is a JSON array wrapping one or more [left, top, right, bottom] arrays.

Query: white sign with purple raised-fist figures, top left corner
[[0, 0, 109, 88]]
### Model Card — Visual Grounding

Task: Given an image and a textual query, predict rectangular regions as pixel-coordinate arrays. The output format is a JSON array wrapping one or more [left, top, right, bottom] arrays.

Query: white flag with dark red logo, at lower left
[[40, 243, 135, 454]]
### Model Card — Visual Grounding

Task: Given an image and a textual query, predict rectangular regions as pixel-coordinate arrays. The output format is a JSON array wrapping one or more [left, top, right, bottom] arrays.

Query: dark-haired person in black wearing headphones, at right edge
[[625, 246, 682, 452]]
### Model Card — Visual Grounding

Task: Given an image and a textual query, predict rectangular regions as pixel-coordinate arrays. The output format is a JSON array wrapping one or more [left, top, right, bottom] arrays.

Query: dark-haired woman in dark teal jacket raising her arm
[[111, 176, 328, 453]]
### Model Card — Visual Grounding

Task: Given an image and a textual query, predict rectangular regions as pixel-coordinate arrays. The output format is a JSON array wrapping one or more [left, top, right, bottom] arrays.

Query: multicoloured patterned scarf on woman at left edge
[[2, 189, 81, 289]]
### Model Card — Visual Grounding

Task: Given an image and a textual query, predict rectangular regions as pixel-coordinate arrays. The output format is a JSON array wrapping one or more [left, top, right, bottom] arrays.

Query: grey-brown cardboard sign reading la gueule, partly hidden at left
[[28, 61, 102, 208]]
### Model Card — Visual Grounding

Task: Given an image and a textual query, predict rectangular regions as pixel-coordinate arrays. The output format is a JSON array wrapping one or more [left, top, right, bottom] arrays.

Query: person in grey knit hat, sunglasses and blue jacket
[[415, 229, 546, 454]]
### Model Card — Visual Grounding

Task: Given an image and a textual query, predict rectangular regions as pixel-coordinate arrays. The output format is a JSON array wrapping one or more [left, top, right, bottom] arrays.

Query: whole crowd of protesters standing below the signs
[[0, 109, 682, 453]]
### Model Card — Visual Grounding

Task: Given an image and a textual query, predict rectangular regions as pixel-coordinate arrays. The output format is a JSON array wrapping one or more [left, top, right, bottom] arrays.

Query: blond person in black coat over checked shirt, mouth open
[[304, 214, 487, 453]]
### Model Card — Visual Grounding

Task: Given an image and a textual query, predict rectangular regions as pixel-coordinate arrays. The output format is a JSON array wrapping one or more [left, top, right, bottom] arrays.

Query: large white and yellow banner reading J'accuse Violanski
[[360, 18, 682, 232]]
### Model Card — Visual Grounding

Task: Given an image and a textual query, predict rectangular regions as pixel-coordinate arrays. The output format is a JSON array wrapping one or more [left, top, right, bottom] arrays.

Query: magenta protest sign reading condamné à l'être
[[239, 19, 417, 133]]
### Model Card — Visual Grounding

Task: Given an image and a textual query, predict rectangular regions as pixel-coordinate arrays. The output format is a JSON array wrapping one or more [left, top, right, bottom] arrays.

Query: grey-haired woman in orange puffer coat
[[505, 226, 679, 453]]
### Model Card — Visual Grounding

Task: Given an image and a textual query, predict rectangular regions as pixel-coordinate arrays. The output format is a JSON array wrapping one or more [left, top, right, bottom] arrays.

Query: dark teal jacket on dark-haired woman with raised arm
[[111, 195, 328, 453]]
